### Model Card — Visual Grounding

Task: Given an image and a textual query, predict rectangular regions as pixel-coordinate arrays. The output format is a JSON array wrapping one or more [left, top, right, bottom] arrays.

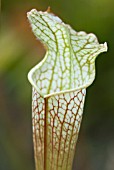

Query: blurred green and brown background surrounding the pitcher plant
[[0, 0, 114, 170]]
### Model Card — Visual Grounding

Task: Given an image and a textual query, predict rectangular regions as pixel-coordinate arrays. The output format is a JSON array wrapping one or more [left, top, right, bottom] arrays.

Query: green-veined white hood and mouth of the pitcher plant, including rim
[[27, 9, 107, 98]]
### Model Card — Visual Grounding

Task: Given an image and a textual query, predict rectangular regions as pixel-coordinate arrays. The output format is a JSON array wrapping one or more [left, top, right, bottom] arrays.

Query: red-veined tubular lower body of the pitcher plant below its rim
[[32, 88, 86, 170]]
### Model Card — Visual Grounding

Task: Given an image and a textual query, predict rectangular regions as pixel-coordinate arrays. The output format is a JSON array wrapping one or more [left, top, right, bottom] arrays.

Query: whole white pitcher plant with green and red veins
[[27, 9, 107, 170]]
